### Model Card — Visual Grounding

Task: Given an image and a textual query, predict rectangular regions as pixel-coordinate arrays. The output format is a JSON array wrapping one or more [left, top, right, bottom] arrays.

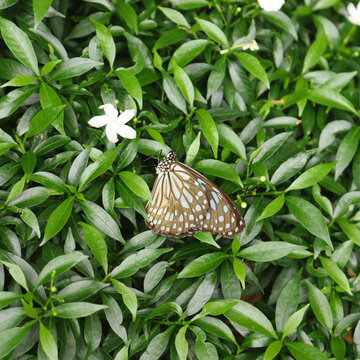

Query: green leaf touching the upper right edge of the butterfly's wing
[[193, 159, 242, 186]]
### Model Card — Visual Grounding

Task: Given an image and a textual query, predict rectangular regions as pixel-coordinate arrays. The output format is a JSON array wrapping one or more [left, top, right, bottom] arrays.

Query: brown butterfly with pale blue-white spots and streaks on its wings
[[145, 151, 245, 239]]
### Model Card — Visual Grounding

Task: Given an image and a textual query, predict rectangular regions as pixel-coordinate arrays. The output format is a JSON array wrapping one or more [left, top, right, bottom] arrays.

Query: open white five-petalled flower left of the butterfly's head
[[89, 104, 136, 144]]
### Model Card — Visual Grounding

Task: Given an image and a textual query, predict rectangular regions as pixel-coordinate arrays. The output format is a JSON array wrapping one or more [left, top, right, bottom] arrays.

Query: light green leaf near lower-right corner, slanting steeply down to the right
[[306, 281, 334, 332]]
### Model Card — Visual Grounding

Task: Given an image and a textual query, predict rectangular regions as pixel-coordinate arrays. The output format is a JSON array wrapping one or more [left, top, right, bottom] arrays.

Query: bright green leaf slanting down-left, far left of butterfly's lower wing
[[40, 196, 75, 245]]
